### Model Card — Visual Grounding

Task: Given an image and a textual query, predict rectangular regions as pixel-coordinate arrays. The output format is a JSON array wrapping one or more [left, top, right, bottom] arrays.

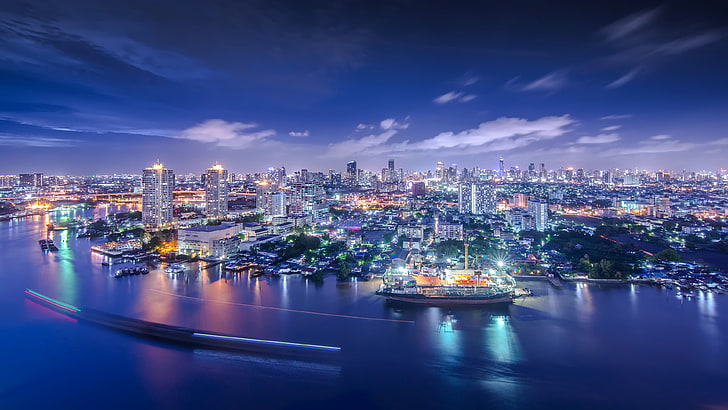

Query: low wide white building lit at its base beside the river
[[177, 222, 243, 258]]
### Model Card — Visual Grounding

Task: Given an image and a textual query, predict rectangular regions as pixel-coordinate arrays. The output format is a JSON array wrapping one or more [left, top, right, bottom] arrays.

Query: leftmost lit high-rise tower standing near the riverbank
[[142, 164, 174, 228]]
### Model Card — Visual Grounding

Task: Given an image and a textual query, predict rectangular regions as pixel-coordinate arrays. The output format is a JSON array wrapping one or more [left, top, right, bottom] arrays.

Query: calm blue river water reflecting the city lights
[[0, 207, 728, 409]]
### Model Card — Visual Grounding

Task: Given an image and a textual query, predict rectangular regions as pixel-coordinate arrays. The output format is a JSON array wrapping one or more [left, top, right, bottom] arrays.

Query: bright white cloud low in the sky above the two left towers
[[177, 119, 275, 149]]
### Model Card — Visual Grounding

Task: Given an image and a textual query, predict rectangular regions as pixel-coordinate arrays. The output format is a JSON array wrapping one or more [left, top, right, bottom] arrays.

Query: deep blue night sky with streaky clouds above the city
[[0, 0, 728, 174]]
